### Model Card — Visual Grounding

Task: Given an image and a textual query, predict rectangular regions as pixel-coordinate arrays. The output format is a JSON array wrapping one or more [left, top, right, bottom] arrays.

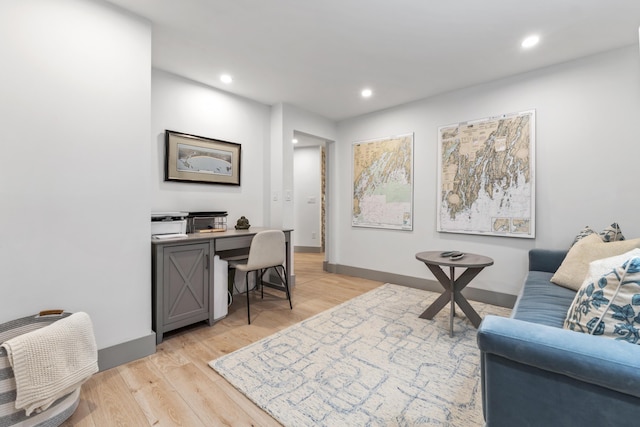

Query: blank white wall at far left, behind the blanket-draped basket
[[0, 0, 151, 348]]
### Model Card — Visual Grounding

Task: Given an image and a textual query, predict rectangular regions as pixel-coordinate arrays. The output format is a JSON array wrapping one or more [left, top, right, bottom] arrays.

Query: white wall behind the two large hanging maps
[[336, 46, 640, 294]]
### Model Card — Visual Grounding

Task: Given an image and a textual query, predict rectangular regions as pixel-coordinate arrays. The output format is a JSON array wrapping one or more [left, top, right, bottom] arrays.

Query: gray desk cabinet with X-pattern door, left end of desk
[[153, 242, 213, 344]]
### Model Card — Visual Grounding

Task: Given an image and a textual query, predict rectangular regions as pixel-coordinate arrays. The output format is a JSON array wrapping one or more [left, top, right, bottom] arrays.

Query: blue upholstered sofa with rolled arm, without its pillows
[[477, 249, 640, 427]]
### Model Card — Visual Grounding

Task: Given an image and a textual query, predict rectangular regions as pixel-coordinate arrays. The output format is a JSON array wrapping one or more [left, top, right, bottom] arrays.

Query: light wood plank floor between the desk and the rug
[[63, 253, 382, 427]]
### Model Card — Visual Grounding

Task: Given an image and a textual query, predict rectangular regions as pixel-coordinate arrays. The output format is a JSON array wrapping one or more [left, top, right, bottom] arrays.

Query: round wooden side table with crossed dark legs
[[416, 251, 493, 337]]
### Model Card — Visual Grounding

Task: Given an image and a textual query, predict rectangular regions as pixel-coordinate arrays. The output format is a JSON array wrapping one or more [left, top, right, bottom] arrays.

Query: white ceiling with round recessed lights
[[109, 0, 640, 120]]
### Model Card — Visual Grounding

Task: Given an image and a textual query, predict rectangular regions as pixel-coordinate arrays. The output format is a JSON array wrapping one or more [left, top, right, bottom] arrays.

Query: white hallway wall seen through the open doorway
[[293, 146, 322, 248]]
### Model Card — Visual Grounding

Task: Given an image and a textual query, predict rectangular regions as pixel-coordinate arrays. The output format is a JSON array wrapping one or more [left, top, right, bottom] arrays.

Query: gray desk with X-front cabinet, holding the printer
[[151, 226, 293, 344]]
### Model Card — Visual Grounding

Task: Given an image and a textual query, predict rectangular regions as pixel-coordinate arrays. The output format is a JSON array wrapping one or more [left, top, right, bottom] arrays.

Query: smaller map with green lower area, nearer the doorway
[[351, 133, 413, 230]]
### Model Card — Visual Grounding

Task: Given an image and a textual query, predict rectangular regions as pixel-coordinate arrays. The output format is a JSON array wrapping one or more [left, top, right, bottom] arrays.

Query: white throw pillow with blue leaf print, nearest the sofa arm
[[564, 256, 640, 344]]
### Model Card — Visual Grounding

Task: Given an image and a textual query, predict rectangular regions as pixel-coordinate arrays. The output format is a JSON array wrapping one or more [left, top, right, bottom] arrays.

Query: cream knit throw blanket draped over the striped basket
[[2, 312, 98, 415]]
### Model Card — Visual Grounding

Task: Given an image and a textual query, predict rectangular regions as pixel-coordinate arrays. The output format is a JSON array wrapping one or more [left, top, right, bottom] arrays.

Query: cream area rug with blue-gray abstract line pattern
[[209, 284, 510, 427]]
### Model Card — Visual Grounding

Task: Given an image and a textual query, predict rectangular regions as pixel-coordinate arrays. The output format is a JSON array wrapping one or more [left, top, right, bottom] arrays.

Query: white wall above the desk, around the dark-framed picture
[[150, 69, 270, 228]]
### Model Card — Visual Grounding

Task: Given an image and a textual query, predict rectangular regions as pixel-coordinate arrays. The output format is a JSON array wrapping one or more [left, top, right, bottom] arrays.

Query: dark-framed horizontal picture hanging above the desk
[[164, 130, 241, 185]]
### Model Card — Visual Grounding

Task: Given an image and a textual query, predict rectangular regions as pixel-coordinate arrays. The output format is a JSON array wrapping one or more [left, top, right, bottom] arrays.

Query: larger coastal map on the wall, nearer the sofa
[[437, 110, 535, 238]]
